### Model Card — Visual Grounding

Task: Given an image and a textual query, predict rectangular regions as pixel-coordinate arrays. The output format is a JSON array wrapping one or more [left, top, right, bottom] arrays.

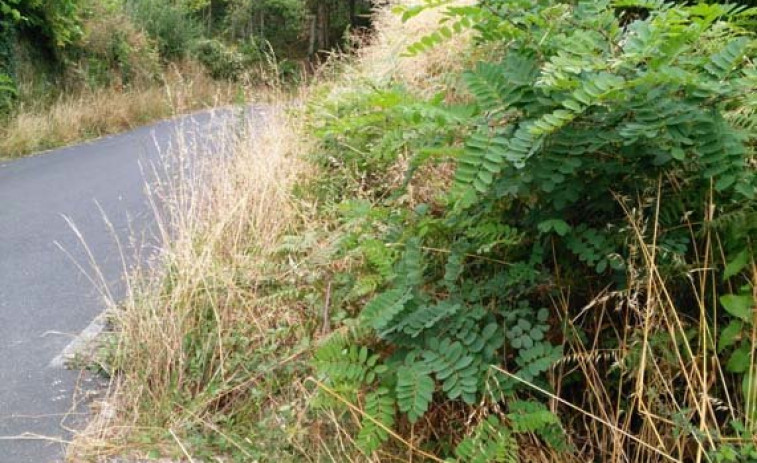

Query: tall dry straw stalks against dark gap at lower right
[[534, 196, 757, 462]]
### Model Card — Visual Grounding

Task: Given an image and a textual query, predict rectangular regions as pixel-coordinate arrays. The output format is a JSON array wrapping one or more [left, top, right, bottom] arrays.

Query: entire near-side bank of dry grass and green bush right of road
[[72, 0, 757, 462]]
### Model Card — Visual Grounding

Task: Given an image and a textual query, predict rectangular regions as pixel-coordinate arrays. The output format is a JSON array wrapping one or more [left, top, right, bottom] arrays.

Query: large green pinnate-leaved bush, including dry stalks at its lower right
[[310, 0, 757, 461]]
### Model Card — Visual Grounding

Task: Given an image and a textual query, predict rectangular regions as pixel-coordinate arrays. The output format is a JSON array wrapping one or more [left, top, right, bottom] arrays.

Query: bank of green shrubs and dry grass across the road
[[0, 0, 367, 156]]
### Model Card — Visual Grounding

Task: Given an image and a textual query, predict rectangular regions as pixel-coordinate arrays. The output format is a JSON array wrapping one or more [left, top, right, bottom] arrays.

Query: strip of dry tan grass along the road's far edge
[[0, 65, 239, 158]]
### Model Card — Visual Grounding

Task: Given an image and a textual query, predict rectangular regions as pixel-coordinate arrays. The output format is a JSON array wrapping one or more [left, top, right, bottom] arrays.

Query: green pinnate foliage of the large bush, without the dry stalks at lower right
[[308, 0, 757, 461]]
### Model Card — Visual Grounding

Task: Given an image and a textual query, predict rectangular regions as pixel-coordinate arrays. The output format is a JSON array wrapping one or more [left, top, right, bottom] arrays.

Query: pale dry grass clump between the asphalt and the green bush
[[70, 99, 308, 460]]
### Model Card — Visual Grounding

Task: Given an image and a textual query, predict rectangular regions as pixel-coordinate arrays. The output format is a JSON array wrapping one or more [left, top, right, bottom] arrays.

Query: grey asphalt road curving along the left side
[[0, 110, 254, 463]]
